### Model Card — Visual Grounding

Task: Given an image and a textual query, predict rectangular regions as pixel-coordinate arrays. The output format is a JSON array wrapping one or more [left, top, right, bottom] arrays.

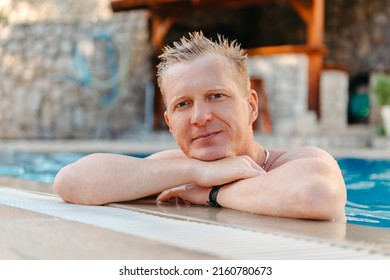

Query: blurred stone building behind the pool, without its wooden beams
[[0, 0, 390, 149]]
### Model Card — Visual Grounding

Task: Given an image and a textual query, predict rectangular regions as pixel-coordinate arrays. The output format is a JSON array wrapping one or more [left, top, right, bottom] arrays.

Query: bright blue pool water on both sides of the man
[[0, 152, 390, 228]]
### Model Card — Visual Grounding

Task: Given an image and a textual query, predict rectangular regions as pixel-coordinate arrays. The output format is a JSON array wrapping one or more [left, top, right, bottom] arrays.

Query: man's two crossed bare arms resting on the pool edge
[[54, 147, 346, 221]]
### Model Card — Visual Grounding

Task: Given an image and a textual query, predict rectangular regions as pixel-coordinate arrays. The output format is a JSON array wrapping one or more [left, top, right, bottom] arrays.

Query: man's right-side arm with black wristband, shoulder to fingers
[[159, 147, 346, 221]]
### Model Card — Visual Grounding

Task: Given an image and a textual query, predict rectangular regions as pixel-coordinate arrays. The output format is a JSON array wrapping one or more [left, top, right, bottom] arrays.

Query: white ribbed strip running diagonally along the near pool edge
[[0, 187, 390, 260]]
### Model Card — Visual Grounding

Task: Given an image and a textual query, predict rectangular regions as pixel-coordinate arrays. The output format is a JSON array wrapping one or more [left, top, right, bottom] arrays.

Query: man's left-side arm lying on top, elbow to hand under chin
[[54, 151, 260, 205]]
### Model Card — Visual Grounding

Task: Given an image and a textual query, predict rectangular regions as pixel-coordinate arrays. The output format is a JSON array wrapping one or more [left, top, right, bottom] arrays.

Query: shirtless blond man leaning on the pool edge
[[54, 33, 346, 221]]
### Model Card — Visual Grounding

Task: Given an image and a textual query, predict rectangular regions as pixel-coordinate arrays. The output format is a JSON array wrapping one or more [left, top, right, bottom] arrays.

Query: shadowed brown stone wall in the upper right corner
[[325, 0, 390, 76]]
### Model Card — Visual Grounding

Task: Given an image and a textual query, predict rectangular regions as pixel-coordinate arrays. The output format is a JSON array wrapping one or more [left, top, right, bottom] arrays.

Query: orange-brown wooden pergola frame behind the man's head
[[111, 0, 327, 128]]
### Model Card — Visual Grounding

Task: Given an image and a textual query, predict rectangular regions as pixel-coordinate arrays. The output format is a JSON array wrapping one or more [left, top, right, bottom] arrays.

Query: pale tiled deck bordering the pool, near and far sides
[[0, 136, 390, 259]]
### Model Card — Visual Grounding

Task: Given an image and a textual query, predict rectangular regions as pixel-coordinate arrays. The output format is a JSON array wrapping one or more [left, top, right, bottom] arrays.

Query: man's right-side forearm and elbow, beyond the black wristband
[[218, 160, 345, 220]]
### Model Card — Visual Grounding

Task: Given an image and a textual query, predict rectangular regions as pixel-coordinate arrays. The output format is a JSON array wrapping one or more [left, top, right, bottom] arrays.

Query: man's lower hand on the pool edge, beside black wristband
[[156, 184, 210, 205]]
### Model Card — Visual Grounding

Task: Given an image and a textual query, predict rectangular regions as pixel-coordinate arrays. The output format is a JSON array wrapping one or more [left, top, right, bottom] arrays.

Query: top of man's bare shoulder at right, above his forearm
[[270, 146, 337, 169]]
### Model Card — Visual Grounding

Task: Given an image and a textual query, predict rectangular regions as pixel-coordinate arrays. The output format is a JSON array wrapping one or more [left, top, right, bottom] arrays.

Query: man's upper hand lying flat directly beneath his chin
[[194, 156, 266, 187]]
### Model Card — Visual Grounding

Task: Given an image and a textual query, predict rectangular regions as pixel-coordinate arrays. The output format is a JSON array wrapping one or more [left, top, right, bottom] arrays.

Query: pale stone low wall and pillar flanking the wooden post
[[247, 54, 349, 136]]
